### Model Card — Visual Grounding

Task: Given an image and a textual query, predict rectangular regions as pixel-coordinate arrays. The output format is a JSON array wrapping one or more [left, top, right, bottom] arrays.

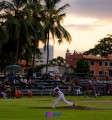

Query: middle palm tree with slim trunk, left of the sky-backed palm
[[26, 0, 45, 72]]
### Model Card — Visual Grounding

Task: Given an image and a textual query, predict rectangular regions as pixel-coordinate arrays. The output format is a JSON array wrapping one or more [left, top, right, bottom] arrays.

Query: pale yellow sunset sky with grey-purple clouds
[[51, 0, 112, 58]]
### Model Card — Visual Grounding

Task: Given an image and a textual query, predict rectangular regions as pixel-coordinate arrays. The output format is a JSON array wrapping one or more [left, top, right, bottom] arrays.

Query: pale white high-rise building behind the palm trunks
[[35, 45, 54, 65]]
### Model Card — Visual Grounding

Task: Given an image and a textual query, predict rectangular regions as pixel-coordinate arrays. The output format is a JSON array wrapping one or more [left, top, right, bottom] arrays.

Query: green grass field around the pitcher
[[0, 96, 112, 120]]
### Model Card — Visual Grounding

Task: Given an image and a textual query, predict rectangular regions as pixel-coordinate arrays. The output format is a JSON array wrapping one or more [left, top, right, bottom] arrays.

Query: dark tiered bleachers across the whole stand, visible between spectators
[[0, 78, 112, 96]]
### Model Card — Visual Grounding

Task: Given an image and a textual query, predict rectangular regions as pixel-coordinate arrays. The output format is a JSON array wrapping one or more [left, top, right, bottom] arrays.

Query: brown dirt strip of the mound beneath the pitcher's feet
[[29, 106, 112, 110]]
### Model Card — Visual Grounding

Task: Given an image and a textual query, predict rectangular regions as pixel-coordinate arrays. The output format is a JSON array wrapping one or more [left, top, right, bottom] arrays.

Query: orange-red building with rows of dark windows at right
[[66, 50, 112, 80]]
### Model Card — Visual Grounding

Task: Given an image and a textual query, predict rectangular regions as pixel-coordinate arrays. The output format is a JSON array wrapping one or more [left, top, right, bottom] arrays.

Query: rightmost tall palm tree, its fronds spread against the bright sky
[[44, 0, 71, 74]]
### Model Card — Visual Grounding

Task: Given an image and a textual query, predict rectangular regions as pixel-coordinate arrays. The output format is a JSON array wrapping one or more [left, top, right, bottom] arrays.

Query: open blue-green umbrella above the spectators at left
[[4, 65, 22, 74]]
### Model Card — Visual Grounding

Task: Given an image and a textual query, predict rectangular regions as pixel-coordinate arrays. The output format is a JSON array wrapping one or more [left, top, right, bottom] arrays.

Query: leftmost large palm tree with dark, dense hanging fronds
[[0, 0, 35, 63]]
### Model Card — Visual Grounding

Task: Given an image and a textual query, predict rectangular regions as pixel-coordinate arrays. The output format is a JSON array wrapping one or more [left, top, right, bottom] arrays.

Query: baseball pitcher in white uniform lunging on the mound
[[52, 84, 75, 108]]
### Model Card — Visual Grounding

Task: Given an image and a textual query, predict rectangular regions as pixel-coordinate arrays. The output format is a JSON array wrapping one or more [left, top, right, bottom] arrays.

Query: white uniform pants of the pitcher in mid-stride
[[53, 93, 73, 108]]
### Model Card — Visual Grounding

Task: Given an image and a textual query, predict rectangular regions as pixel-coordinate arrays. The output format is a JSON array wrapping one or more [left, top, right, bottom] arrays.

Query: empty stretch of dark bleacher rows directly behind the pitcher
[[18, 79, 67, 96]]
